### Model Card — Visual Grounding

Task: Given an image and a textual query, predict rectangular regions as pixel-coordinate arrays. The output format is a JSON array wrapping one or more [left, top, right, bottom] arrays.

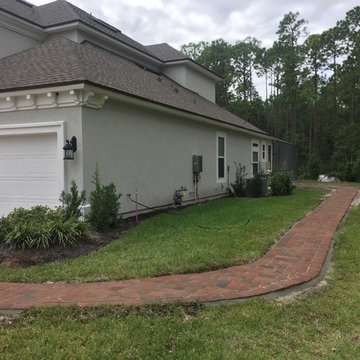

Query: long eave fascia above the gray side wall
[[85, 84, 275, 140]]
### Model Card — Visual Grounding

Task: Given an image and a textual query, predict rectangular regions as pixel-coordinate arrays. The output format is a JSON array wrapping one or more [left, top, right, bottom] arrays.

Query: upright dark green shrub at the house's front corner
[[88, 166, 121, 230]]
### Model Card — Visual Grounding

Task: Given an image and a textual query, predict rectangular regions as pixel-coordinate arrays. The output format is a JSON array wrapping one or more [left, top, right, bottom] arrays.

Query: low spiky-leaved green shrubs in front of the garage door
[[0, 205, 91, 249]]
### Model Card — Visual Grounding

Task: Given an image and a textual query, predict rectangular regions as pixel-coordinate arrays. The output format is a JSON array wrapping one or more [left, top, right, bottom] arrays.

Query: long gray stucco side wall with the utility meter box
[[82, 101, 271, 212]]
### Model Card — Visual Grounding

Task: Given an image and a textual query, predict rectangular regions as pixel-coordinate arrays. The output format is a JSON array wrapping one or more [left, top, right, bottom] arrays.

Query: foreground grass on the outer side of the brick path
[[0, 198, 360, 360]]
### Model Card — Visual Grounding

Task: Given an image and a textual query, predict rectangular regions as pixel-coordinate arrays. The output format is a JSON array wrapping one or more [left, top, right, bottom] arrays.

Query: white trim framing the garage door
[[0, 121, 65, 200]]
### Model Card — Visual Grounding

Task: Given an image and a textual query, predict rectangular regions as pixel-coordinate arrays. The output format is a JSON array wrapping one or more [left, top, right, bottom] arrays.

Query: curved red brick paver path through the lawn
[[0, 186, 357, 310]]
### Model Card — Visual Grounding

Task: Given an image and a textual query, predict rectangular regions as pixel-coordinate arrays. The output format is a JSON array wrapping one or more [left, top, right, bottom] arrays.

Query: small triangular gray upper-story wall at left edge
[[0, 25, 39, 59]]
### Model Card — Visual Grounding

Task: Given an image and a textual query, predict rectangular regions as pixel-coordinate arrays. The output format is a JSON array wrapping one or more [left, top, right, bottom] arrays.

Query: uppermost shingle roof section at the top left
[[0, 0, 156, 57]]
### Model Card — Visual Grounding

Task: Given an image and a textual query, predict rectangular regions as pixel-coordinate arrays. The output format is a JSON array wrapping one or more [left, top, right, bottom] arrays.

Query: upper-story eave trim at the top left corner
[[0, 9, 46, 41]]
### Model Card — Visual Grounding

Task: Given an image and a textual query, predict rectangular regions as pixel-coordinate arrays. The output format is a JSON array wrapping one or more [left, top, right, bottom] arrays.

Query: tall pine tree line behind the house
[[181, 6, 360, 180]]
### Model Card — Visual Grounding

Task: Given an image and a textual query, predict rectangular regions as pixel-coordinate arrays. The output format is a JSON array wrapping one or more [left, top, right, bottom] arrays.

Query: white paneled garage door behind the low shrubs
[[0, 133, 61, 216]]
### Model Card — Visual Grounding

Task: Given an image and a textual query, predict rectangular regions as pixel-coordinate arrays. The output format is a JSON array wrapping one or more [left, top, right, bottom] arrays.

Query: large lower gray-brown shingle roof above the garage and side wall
[[0, 38, 264, 133]]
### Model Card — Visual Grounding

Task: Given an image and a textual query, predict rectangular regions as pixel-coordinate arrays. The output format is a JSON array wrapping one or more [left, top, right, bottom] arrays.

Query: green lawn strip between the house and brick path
[[0, 189, 324, 282]]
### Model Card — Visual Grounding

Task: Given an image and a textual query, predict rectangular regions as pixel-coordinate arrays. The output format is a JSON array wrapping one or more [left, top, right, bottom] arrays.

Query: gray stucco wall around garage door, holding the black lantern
[[0, 107, 83, 195]]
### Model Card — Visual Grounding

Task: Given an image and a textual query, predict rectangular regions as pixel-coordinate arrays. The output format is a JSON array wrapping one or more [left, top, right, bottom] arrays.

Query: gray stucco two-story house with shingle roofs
[[0, 0, 273, 215]]
